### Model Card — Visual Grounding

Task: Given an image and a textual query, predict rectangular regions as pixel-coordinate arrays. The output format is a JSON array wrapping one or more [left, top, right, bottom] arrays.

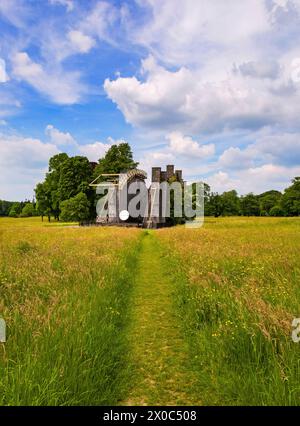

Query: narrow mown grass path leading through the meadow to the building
[[121, 232, 200, 405]]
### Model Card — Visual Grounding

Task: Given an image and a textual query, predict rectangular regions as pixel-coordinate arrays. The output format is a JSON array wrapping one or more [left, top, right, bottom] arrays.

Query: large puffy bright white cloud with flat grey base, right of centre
[[104, 57, 294, 133]]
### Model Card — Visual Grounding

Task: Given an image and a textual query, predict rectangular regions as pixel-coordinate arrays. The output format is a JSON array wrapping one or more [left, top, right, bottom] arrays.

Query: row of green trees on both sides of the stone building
[[0, 143, 300, 222]]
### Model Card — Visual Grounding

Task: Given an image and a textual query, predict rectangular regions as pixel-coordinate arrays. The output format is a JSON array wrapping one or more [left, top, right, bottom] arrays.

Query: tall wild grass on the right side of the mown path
[[159, 218, 300, 405]]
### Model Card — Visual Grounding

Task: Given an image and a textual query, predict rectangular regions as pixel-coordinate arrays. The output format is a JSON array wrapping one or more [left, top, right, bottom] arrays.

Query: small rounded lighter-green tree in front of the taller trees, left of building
[[60, 192, 90, 222]]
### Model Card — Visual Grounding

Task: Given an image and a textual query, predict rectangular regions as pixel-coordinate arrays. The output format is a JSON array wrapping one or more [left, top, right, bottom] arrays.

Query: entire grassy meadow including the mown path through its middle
[[0, 218, 300, 405]]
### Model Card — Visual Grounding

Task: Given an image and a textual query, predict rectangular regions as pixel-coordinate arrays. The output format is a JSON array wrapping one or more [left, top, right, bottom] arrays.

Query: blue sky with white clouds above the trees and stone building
[[0, 0, 300, 200]]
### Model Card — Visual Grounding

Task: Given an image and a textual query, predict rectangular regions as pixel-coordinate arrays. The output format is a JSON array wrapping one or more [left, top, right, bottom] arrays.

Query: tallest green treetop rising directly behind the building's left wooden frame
[[94, 143, 138, 178]]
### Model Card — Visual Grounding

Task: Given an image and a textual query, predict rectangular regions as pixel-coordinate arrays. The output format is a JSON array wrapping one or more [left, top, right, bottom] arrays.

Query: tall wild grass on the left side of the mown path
[[0, 219, 141, 405]]
